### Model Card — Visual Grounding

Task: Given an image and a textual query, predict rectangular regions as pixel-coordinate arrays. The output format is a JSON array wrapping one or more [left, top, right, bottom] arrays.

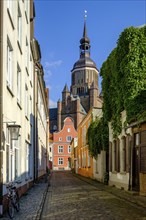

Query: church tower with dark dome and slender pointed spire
[[71, 18, 101, 112]]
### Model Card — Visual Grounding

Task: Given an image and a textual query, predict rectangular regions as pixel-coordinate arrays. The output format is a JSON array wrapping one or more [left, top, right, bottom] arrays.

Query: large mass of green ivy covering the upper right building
[[100, 26, 146, 137]]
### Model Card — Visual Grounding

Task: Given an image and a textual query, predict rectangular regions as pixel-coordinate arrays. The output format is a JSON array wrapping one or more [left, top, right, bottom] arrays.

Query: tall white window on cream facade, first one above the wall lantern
[[7, 39, 13, 91]]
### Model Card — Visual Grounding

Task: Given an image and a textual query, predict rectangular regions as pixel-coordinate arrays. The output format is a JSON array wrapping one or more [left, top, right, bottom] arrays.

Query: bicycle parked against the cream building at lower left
[[6, 182, 20, 219]]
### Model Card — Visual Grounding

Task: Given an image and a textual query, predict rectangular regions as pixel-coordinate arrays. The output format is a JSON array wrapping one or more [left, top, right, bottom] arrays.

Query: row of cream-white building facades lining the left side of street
[[0, 0, 48, 214]]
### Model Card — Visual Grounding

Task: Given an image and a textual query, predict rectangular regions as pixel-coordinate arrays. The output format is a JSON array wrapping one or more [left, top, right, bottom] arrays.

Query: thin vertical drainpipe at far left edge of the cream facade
[[0, 1, 3, 217]]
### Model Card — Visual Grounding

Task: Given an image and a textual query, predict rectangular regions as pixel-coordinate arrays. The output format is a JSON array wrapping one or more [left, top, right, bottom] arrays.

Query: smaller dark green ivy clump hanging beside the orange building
[[87, 118, 109, 158]]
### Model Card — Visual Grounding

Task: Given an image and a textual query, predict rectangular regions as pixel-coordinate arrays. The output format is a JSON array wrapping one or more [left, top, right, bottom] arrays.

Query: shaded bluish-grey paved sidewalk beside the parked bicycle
[[1, 176, 50, 220]]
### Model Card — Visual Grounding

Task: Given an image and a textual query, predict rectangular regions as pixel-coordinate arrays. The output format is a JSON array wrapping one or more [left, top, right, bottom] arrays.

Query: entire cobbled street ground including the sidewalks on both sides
[[2, 171, 146, 220]]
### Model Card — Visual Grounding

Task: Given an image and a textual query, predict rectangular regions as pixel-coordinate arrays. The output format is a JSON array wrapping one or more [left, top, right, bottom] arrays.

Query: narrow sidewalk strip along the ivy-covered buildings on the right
[[73, 174, 146, 208]]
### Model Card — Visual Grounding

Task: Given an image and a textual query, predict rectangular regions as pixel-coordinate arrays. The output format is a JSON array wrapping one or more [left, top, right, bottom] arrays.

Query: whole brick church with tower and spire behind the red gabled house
[[50, 20, 102, 133]]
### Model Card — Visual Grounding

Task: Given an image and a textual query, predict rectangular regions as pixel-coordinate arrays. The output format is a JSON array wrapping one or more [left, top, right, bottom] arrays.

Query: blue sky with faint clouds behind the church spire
[[34, 0, 146, 108]]
